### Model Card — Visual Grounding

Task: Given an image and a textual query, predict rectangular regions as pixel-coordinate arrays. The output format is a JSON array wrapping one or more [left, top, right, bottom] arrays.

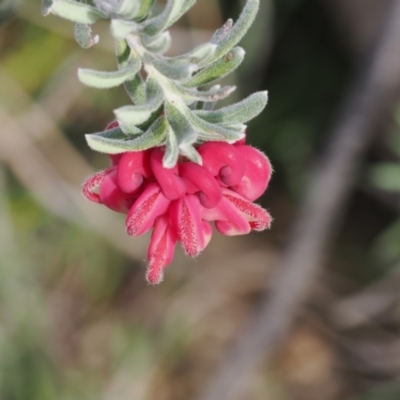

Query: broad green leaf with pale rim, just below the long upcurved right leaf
[[185, 47, 245, 87]]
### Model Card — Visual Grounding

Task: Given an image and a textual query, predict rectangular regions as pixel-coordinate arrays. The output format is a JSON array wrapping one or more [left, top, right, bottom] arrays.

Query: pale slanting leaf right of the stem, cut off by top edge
[[143, 0, 196, 36]]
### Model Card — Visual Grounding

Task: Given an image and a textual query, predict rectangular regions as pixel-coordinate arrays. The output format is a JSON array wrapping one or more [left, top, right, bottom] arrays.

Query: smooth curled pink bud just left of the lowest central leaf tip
[[150, 148, 186, 200]]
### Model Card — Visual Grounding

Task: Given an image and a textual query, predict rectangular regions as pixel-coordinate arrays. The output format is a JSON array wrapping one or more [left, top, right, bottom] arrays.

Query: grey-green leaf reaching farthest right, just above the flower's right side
[[194, 92, 268, 124]]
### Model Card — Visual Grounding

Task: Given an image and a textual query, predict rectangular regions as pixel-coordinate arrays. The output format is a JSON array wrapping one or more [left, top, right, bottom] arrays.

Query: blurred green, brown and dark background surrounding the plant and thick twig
[[0, 0, 400, 400]]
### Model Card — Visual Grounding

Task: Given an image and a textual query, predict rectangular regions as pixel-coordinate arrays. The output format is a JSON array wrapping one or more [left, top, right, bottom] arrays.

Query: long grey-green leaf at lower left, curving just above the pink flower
[[85, 118, 169, 154]]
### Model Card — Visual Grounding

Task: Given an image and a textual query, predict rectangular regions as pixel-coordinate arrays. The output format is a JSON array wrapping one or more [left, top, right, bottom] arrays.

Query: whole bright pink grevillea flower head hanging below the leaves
[[83, 123, 272, 284]]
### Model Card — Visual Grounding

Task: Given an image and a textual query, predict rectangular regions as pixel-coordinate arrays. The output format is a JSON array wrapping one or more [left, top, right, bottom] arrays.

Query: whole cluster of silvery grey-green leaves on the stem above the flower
[[42, 0, 267, 168]]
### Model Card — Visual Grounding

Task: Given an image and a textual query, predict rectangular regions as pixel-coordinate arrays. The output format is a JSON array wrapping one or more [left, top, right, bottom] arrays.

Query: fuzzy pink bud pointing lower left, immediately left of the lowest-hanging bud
[[126, 183, 170, 236]]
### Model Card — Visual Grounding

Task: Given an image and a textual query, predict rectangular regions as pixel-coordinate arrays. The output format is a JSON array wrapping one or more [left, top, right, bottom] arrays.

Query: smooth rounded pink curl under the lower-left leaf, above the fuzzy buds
[[118, 151, 152, 193]]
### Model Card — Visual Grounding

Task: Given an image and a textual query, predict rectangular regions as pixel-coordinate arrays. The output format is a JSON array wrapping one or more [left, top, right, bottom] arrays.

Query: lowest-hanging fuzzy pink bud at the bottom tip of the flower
[[146, 215, 177, 285]]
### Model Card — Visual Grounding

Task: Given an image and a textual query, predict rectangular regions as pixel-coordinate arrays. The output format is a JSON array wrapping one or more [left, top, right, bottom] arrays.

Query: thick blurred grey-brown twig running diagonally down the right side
[[197, 0, 400, 400]]
